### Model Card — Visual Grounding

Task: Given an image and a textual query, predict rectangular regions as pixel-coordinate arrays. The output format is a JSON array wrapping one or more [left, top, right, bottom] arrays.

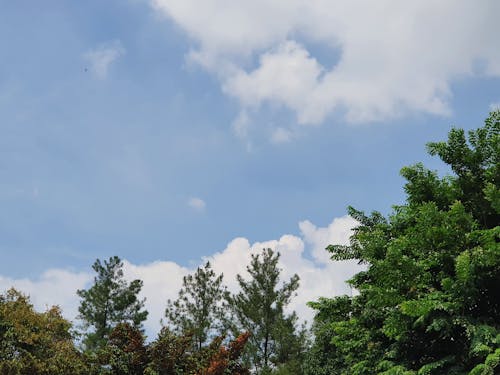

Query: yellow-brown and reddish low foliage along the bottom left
[[0, 268, 250, 375]]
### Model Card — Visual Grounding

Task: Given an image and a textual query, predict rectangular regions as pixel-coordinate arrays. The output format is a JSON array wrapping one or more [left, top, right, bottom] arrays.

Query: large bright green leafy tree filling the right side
[[306, 111, 500, 374]]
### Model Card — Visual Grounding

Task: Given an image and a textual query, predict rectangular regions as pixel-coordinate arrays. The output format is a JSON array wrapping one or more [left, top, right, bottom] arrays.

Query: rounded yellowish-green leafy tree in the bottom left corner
[[0, 289, 88, 375]]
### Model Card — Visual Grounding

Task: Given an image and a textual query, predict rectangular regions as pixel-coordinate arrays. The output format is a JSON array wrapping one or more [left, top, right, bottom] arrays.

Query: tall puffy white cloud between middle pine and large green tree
[[206, 217, 362, 322]]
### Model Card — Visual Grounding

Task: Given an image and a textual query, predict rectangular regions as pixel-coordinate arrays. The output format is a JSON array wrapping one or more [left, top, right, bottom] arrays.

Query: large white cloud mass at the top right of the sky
[[151, 0, 500, 134]]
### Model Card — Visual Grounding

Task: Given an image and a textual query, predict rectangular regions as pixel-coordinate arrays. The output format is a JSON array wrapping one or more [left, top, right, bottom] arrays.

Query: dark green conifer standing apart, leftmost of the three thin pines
[[77, 256, 148, 350]]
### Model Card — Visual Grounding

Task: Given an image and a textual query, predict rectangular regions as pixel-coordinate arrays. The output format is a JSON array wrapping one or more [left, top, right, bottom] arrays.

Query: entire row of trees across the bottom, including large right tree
[[0, 111, 500, 375]]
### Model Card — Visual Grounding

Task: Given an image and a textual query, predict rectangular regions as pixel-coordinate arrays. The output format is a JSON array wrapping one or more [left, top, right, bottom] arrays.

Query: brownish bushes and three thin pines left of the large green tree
[[0, 249, 306, 375]]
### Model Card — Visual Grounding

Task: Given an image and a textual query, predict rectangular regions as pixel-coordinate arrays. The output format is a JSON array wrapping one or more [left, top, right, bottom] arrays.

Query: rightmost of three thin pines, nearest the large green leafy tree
[[229, 249, 304, 373]]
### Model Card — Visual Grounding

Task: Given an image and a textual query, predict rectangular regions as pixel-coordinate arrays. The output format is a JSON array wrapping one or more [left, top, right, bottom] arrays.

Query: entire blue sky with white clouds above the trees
[[0, 0, 500, 333]]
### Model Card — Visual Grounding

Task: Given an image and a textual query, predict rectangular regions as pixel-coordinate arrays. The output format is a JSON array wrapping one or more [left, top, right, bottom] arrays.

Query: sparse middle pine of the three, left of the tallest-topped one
[[165, 262, 227, 350]]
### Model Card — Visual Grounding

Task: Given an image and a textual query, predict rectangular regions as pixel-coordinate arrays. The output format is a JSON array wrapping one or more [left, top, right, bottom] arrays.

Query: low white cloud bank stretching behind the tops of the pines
[[0, 216, 361, 337]]
